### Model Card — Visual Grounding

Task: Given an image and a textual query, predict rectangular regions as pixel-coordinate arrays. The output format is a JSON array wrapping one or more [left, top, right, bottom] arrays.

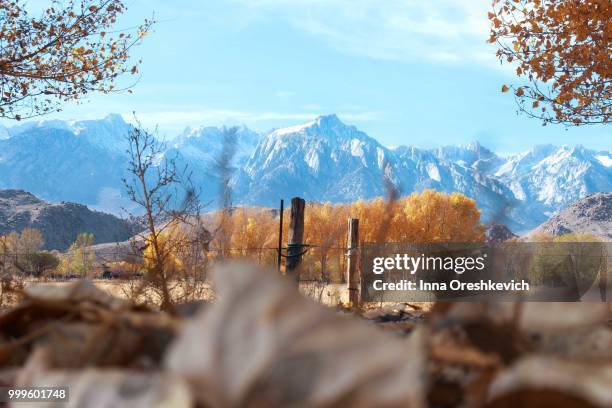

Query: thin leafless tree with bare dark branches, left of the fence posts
[[123, 116, 202, 311]]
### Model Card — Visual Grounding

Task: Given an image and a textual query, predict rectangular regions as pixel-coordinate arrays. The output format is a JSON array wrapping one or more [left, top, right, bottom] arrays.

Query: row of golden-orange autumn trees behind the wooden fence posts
[[211, 190, 484, 280]]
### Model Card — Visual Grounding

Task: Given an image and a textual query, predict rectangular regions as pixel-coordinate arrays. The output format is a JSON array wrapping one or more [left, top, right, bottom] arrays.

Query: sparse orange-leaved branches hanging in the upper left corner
[[0, 0, 152, 120]]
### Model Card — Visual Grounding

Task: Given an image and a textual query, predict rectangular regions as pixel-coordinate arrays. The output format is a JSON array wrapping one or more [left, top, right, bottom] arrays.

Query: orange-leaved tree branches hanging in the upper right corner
[[489, 0, 612, 125]]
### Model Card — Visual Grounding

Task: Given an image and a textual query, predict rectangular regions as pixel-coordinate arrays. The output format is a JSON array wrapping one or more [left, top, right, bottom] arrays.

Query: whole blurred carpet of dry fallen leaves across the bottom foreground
[[0, 264, 612, 407]]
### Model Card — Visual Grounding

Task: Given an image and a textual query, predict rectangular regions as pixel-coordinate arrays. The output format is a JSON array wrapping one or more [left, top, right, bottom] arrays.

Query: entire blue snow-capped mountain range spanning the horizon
[[0, 114, 612, 232]]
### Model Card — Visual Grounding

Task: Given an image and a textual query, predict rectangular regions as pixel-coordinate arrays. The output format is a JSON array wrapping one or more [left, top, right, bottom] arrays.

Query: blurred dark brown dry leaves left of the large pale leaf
[[0, 282, 178, 368]]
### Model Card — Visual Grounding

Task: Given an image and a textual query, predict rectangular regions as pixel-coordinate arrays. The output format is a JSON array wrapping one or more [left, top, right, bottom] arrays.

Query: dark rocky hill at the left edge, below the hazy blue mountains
[[0, 190, 133, 251]]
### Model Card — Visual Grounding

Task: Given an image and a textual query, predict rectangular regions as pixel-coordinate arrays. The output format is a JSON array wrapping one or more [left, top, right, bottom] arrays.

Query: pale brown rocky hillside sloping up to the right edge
[[529, 193, 612, 240]]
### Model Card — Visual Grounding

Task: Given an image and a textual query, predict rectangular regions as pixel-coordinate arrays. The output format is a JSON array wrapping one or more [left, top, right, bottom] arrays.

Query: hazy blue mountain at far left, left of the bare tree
[[0, 122, 126, 211]]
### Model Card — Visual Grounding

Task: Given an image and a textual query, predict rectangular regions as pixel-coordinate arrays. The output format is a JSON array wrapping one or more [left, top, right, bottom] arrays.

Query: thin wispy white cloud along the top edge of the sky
[[234, 0, 497, 65]]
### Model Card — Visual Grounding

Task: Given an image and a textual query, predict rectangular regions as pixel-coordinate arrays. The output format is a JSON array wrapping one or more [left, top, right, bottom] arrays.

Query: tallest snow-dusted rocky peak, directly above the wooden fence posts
[[234, 115, 391, 205]]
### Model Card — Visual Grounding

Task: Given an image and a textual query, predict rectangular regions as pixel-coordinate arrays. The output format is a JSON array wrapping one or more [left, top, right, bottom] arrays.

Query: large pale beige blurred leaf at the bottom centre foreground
[[167, 264, 427, 408]]
